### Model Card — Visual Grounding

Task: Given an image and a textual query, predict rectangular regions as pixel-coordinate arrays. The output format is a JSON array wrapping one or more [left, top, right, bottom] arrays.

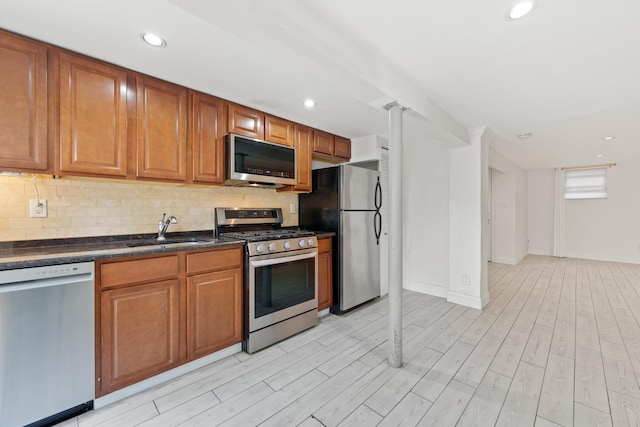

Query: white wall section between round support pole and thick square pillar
[[402, 142, 450, 297]]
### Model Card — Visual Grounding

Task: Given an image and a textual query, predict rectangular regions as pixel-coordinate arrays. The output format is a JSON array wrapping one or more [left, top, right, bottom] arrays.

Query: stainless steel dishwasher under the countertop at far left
[[0, 262, 95, 427]]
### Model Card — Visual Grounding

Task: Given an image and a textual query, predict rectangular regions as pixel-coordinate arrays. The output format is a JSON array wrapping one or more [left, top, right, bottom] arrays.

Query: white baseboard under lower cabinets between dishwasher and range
[[93, 343, 242, 409]]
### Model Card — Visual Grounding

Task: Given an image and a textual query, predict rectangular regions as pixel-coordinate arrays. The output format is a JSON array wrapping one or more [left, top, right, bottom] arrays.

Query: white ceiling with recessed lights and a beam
[[0, 0, 640, 168]]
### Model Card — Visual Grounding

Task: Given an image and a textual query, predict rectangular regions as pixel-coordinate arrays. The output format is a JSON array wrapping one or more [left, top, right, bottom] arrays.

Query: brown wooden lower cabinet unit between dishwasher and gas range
[[96, 246, 242, 397]]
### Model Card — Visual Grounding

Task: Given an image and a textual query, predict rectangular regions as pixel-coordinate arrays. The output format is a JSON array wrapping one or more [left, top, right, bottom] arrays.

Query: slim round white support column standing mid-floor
[[384, 102, 405, 368]]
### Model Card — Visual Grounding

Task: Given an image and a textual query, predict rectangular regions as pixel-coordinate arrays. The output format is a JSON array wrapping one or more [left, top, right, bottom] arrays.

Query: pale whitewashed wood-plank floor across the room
[[60, 256, 640, 427]]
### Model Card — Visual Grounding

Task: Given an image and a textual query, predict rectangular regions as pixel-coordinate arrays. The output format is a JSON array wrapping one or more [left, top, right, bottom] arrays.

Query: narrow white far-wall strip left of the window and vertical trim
[[527, 169, 555, 256]]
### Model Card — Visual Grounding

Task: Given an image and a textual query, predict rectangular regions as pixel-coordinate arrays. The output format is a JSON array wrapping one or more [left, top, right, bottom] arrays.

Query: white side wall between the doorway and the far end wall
[[489, 149, 528, 264]]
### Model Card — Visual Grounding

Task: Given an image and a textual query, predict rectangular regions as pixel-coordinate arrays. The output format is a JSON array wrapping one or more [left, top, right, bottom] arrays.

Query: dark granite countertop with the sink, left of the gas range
[[0, 230, 244, 270]]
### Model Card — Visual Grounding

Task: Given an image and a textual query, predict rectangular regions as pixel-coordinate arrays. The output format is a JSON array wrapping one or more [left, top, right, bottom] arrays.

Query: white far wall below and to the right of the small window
[[565, 161, 640, 263]]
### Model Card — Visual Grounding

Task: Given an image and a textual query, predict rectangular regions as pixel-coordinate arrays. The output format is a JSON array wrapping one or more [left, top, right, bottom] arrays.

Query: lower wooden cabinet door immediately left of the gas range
[[187, 268, 242, 360]]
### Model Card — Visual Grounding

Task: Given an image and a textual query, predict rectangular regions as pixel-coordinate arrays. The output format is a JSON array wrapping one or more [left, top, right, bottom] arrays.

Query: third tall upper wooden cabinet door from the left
[[136, 75, 187, 181]]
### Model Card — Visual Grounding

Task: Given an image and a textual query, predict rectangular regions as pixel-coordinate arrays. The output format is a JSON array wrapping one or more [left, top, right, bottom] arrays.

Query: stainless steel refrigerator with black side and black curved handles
[[298, 162, 382, 313]]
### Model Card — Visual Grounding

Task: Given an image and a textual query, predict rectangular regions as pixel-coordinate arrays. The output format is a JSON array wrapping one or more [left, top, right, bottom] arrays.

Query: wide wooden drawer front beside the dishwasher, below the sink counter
[[100, 255, 179, 288]]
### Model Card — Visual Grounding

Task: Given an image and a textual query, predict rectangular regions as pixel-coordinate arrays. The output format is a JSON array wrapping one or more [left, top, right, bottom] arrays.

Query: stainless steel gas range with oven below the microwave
[[216, 208, 318, 353]]
